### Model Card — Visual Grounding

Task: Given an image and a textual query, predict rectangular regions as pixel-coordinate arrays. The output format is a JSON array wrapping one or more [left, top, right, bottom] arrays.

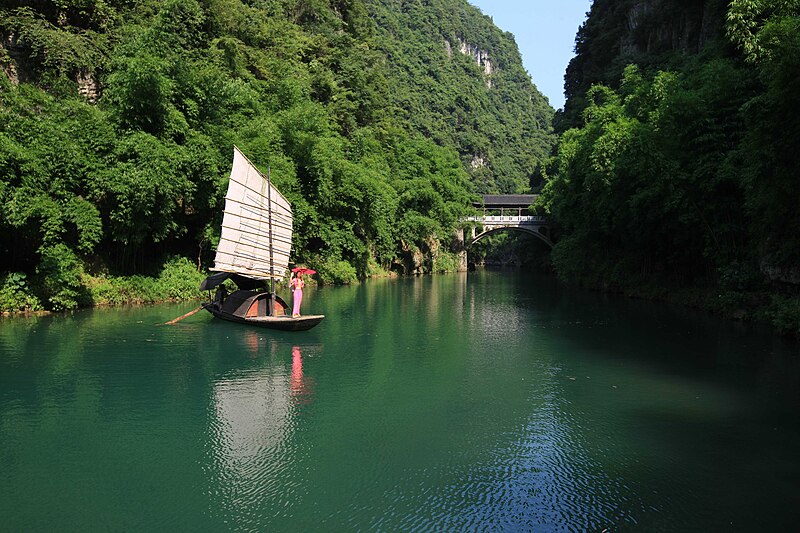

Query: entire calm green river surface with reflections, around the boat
[[0, 271, 800, 532]]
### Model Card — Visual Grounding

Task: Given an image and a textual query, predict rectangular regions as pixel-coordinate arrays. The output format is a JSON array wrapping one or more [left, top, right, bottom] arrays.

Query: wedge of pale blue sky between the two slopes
[[467, 0, 592, 109]]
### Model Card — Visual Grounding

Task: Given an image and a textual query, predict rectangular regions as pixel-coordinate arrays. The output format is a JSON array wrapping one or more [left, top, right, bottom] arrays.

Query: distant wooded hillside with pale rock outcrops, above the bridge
[[367, 0, 553, 193]]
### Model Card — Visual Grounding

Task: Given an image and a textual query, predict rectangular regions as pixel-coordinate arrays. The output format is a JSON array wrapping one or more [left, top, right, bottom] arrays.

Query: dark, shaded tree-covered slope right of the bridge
[[539, 0, 800, 331]]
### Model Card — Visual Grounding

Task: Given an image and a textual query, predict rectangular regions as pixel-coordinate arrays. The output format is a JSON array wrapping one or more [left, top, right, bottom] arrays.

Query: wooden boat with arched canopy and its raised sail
[[200, 146, 325, 331]]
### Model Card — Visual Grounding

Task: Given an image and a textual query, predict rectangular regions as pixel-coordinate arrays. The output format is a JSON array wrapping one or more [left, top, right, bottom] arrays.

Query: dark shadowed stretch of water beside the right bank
[[484, 272, 800, 530]]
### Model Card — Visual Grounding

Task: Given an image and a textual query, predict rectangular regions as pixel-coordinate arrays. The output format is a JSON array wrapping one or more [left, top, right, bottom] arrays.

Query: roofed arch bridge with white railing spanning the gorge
[[464, 194, 553, 248]]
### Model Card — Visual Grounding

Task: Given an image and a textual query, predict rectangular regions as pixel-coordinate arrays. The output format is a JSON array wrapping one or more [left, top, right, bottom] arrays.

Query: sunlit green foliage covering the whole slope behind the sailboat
[[0, 0, 552, 310]]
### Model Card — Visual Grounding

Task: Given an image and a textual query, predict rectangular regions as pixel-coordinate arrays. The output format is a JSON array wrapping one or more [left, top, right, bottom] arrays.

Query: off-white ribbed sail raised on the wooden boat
[[211, 146, 292, 279]]
